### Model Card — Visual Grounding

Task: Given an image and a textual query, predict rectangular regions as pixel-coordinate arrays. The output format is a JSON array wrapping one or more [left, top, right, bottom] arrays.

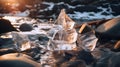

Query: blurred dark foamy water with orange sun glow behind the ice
[[0, 0, 120, 21]]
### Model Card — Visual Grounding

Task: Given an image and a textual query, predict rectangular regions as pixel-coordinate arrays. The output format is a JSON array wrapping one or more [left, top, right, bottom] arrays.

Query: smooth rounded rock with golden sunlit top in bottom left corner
[[0, 53, 40, 67]]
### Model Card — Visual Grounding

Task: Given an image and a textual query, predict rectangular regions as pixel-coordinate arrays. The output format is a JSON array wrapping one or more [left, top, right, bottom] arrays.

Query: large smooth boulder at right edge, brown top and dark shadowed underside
[[95, 17, 120, 40]]
